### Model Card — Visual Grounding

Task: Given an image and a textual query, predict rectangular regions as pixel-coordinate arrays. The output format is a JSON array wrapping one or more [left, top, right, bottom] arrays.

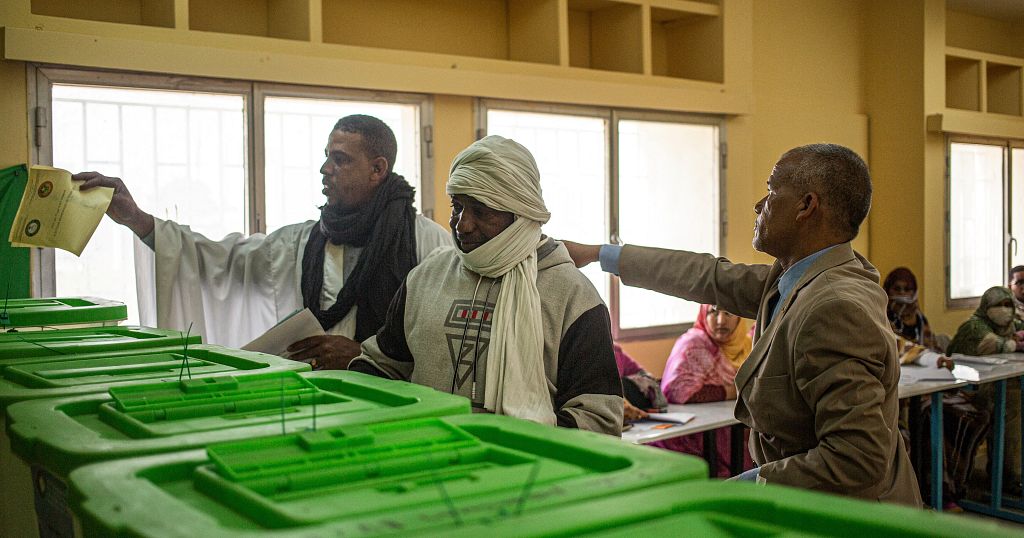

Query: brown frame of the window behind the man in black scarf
[[26, 64, 434, 297]]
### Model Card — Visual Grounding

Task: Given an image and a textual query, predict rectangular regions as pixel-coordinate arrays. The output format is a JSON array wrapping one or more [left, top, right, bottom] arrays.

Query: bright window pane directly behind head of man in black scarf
[[263, 96, 423, 233]]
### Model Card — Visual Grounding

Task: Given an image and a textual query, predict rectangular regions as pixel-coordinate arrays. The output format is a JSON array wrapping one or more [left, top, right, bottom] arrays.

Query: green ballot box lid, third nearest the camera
[[7, 370, 470, 478]]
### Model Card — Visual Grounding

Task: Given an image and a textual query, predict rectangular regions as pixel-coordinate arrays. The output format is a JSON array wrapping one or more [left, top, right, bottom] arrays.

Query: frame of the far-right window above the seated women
[[944, 134, 1024, 308]]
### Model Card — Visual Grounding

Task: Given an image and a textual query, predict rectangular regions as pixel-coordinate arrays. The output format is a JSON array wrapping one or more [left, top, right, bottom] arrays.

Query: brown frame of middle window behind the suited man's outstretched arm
[[475, 98, 728, 341]]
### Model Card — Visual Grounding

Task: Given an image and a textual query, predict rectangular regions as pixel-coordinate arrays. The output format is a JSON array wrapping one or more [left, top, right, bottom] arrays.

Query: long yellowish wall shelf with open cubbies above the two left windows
[[0, 0, 753, 114]]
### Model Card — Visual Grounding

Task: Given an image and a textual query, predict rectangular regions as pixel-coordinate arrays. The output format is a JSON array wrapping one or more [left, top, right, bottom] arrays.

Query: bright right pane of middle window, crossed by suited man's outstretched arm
[[618, 120, 720, 329]]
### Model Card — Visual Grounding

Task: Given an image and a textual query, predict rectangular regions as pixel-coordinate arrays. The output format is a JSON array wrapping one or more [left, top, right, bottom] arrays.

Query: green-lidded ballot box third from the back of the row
[[0, 344, 309, 536]]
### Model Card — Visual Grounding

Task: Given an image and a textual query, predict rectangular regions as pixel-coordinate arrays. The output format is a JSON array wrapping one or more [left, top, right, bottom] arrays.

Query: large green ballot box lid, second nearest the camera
[[70, 414, 708, 536]]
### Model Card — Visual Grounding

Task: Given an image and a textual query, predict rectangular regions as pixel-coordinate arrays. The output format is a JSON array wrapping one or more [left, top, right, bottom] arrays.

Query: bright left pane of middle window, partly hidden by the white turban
[[487, 110, 608, 302]]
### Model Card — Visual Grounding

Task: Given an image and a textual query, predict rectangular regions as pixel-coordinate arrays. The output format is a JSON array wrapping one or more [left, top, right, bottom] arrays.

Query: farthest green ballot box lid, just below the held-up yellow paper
[[0, 326, 203, 364]]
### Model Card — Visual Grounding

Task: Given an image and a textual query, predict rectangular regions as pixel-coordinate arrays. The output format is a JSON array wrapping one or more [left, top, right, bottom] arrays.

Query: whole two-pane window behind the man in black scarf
[[35, 68, 431, 324]]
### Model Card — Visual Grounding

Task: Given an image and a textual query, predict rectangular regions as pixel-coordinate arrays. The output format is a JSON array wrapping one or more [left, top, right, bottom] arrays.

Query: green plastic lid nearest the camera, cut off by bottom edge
[[436, 481, 1011, 538]]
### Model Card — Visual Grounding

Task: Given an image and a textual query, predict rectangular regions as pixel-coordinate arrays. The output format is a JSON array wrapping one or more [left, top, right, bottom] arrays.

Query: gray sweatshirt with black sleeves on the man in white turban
[[349, 238, 623, 436]]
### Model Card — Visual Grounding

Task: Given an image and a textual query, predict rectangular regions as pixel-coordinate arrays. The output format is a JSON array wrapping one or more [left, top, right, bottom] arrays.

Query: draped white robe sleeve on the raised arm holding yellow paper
[[155, 218, 313, 347]]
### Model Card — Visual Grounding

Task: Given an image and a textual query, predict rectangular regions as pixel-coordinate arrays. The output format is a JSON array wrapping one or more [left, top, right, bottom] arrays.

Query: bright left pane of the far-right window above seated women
[[949, 143, 1006, 299]]
